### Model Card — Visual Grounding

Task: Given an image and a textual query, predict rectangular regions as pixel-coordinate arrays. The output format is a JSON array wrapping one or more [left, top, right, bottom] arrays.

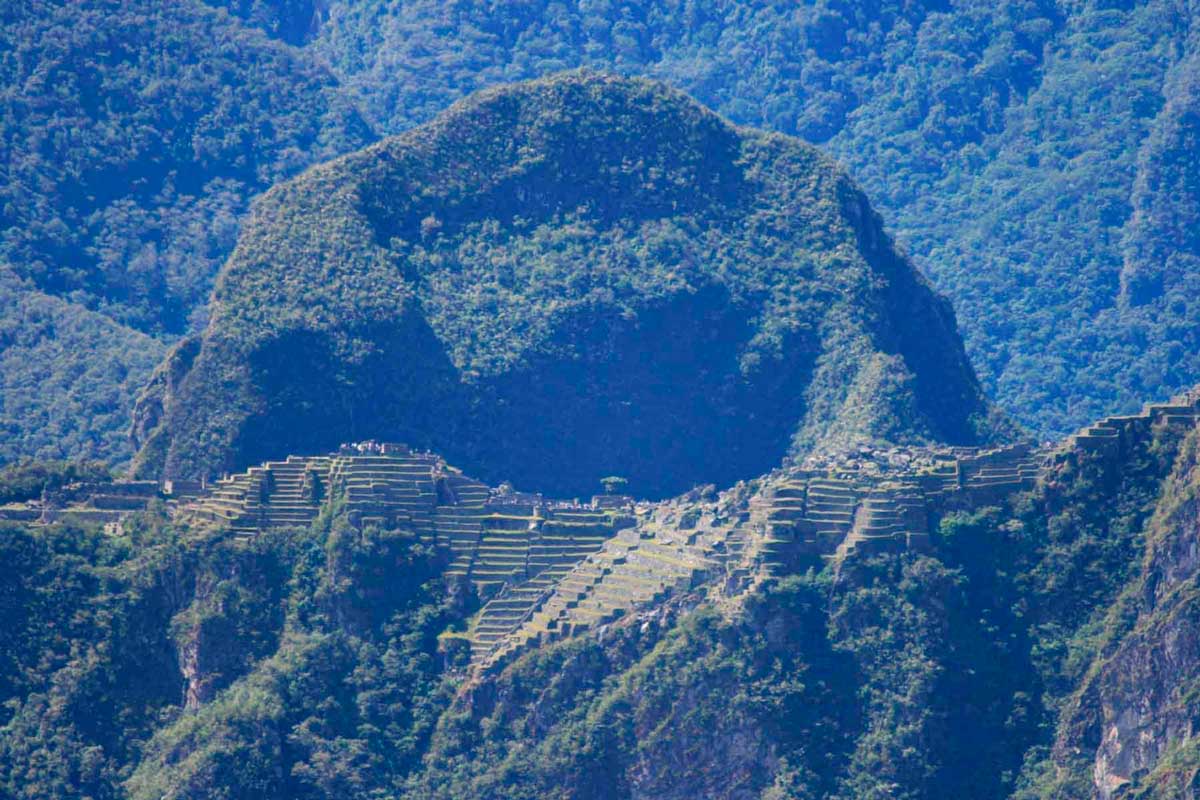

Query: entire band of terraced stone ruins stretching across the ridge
[[9, 392, 1200, 668]]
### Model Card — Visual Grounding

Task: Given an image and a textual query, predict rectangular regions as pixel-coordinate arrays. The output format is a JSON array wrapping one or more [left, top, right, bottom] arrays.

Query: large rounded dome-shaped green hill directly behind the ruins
[[136, 73, 1004, 497]]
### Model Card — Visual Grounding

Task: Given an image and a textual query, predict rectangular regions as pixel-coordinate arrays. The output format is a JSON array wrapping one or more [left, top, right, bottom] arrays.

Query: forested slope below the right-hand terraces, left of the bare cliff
[[398, 410, 1200, 800]]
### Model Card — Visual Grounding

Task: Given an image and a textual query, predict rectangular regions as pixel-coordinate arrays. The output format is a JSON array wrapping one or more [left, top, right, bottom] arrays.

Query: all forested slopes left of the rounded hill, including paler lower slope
[[0, 0, 372, 459]]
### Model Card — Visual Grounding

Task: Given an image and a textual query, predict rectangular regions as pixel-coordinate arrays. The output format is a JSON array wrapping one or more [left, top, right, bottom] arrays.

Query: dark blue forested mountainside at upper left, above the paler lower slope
[[0, 1, 371, 332]]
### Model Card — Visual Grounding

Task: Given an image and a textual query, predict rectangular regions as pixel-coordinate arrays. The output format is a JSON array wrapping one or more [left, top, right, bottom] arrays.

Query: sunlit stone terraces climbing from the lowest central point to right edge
[[474, 395, 1200, 669]]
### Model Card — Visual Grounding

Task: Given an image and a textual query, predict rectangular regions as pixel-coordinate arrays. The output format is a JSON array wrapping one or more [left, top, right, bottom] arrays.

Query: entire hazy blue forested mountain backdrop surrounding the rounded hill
[[7, 0, 1200, 470]]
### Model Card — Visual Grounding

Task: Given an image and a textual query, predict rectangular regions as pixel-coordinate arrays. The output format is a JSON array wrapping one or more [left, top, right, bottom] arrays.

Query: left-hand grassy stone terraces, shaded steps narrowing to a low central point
[[178, 445, 632, 655]]
